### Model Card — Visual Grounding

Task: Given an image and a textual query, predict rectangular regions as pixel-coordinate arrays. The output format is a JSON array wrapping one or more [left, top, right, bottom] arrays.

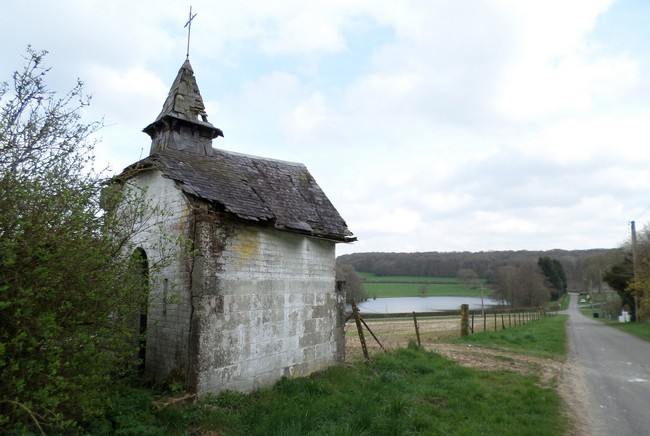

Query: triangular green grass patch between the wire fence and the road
[[449, 315, 568, 359]]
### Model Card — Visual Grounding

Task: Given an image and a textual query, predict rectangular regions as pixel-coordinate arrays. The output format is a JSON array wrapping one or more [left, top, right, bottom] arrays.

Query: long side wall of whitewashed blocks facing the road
[[193, 214, 344, 395]]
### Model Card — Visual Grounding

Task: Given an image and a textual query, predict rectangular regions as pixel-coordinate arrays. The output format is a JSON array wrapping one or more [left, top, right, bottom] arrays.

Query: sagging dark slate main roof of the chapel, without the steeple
[[122, 149, 356, 242]]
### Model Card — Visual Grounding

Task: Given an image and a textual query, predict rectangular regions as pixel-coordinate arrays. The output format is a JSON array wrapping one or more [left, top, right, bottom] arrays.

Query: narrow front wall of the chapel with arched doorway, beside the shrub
[[127, 170, 193, 381]]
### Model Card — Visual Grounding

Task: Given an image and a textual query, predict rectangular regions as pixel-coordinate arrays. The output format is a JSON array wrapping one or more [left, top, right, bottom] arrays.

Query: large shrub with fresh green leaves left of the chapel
[[0, 47, 151, 432]]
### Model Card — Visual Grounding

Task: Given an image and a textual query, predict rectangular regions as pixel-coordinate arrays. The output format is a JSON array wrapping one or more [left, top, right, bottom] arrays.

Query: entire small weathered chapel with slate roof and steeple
[[112, 60, 355, 395]]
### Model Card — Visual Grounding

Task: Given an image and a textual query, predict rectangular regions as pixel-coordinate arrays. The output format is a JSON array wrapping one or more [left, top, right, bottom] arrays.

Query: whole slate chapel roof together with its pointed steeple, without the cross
[[118, 60, 356, 242]]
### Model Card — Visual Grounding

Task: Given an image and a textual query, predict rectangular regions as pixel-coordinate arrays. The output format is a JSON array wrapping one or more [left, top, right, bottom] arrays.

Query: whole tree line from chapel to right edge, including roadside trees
[[337, 242, 650, 321]]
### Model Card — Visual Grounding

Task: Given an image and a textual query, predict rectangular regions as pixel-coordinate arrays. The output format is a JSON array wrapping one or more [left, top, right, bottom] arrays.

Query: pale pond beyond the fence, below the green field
[[348, 297, 501, 313]]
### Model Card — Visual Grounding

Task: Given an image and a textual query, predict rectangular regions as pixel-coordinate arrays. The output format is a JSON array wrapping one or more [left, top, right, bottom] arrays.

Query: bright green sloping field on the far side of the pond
[[359, 272, 490, 298]]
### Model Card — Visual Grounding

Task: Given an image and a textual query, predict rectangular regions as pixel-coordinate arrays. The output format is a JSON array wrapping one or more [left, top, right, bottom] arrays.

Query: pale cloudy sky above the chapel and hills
[[0, 0, 650, 254]]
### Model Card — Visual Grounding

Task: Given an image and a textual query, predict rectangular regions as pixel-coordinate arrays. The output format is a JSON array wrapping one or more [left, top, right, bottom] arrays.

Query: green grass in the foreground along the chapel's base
[[98, 346, 568, 435]]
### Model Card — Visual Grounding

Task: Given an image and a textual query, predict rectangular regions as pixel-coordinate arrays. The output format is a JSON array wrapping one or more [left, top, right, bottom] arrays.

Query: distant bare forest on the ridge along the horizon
[[337, 248, 622, 291]]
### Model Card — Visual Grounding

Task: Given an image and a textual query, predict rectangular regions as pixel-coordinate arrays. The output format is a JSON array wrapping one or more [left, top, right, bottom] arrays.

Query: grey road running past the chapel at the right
[[564, 294, 650, 436]]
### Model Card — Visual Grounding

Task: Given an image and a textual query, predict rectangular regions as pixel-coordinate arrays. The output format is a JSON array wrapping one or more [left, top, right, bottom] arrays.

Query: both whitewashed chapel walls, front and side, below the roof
[[121, 170, 344, 394]]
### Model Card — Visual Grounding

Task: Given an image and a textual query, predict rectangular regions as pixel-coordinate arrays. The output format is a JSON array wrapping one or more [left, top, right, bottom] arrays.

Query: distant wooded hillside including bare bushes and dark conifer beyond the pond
[[337, 248, 623, 307]]
